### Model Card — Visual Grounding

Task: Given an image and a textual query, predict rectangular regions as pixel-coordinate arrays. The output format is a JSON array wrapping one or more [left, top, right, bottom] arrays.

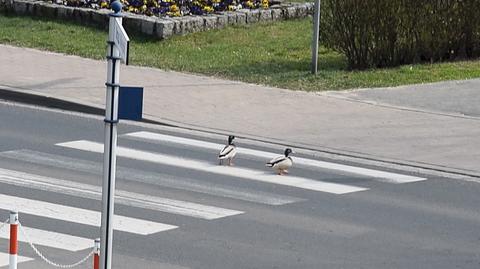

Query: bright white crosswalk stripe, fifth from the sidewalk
[[0, 194, 178, 235]]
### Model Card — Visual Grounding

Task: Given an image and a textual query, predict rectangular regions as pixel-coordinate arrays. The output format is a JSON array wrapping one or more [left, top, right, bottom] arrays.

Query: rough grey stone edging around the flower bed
[[0, 0, 313, 39]]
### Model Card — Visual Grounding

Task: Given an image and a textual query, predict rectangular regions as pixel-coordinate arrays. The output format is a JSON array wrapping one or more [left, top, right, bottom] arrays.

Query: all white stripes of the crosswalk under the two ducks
[[0, 132, 425, 267]]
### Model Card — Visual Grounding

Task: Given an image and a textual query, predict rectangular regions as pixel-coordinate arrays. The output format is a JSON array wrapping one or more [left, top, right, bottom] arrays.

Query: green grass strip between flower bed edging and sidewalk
[[0, 15, 480, 91]]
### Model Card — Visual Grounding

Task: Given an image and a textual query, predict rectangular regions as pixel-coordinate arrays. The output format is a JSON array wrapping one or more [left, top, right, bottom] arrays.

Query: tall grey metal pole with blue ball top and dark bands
[[100, 5, 122, 269]]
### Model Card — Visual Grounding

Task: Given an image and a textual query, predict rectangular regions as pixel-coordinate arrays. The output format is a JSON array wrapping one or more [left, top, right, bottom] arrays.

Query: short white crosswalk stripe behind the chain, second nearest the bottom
[[0, 223, 93, 251]]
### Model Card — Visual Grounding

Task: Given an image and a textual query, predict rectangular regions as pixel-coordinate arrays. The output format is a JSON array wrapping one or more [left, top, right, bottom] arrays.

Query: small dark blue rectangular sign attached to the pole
[[118, 87, 143, 120]]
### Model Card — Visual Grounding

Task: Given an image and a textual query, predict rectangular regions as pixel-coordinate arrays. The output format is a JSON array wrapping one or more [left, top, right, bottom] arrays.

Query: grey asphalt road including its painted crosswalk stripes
[[0, 102, 480, 269]]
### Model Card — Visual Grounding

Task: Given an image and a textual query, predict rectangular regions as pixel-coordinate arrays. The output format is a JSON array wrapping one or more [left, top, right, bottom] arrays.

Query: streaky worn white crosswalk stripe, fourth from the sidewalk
[[0, 168, 244, 220]]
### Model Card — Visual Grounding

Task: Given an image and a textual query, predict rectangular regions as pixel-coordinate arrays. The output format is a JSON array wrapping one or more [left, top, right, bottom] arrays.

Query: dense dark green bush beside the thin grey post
[[320, 0, 480, 69]]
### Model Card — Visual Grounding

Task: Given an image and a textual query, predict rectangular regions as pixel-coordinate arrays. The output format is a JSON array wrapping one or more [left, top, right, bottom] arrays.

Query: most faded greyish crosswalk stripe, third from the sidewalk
[[0, 150, 305, 205]]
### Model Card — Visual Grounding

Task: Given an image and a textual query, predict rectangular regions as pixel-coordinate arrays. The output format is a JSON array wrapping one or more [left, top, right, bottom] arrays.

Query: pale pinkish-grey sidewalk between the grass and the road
[[0, 45, 480, 177]]
